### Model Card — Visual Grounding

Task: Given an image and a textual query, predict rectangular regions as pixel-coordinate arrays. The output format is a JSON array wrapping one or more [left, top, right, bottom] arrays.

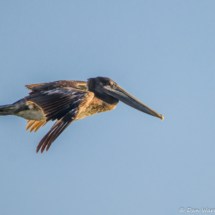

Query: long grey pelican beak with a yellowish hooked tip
[[104, 86, 164, 120]]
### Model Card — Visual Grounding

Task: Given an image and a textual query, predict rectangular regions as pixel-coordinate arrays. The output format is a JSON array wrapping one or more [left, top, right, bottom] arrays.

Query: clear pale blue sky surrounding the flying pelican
[[0, 0, 215, 215]]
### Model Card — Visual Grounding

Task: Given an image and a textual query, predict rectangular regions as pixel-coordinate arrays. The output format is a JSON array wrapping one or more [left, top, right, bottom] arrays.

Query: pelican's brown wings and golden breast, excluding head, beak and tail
[[25, 81, 118, 152]]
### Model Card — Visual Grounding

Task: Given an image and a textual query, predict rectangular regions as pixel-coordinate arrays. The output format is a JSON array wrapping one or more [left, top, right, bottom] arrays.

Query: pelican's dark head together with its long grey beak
[[87, 77, 164, 120]]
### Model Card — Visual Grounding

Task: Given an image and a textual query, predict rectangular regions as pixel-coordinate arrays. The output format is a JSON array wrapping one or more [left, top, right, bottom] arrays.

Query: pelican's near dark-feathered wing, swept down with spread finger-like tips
[[25, 87, 94, 153]]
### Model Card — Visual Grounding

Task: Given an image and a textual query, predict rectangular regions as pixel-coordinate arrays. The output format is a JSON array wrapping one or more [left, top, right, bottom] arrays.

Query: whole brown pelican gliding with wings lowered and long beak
[[0, 77, 164, 153]]
